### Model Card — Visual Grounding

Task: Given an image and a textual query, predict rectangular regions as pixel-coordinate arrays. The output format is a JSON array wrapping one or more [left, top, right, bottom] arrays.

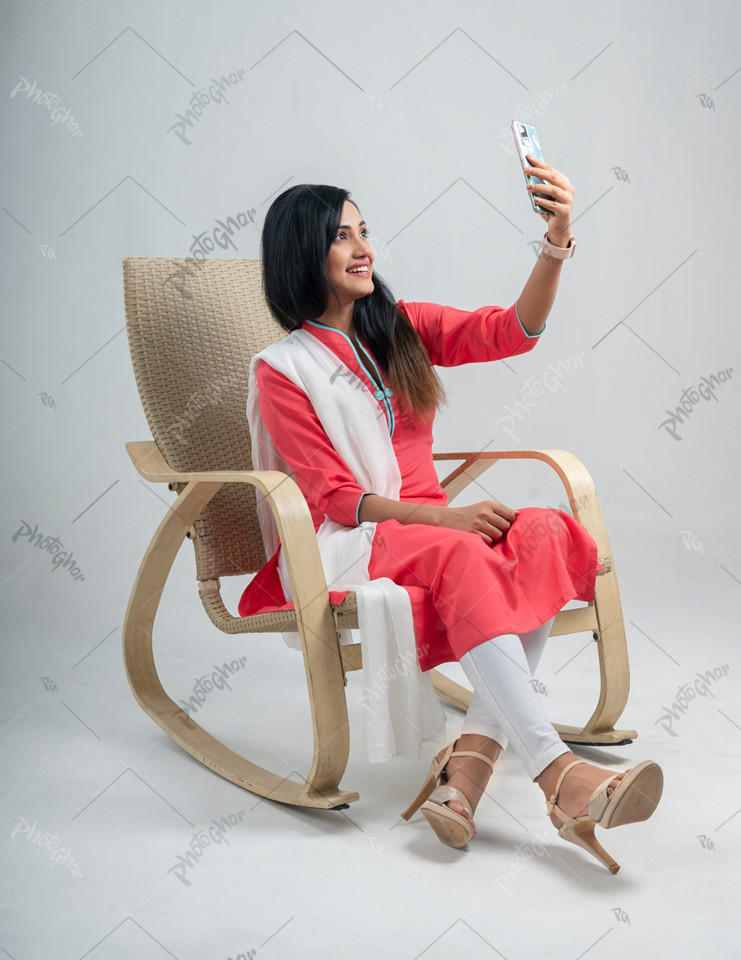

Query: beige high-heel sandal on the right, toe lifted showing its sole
[[546, 760, 664, 873]]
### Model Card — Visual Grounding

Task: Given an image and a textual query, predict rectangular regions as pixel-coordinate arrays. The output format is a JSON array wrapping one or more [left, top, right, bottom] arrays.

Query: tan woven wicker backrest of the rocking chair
[[123, 257, 288, 580]]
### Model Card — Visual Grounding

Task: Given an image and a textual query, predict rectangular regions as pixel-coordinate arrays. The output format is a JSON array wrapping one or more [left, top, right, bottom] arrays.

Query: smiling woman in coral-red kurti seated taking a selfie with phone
[[239, 167, 663, 873]]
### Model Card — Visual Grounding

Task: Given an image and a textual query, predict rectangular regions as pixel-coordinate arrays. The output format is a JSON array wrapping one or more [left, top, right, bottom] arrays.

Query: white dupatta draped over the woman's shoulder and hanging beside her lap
[[247, 329, 445, 762]]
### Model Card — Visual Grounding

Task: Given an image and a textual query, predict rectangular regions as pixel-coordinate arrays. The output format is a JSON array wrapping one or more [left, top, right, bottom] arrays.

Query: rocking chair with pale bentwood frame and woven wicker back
[[123, 257, 637, 809]]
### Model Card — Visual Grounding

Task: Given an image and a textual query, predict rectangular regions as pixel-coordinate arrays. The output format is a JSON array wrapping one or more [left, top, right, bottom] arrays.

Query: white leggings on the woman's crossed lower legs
[[460, 617, 569, 780]]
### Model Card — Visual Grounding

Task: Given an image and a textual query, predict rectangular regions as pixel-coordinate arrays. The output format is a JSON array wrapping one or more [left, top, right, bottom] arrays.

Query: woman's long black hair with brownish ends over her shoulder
[[261, 183, 447, 419]]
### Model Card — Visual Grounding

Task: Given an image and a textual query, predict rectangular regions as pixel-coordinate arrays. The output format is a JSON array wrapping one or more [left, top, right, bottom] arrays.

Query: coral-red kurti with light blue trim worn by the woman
[[238, 300, 602, 671]]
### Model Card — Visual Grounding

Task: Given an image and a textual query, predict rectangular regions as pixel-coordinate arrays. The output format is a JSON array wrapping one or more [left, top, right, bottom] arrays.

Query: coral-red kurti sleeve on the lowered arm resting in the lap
[[257, 360, 373, 527]]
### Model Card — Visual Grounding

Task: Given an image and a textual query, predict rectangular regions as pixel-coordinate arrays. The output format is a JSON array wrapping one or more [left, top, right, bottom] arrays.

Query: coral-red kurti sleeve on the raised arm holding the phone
[[396, 300, 545, 367]]
